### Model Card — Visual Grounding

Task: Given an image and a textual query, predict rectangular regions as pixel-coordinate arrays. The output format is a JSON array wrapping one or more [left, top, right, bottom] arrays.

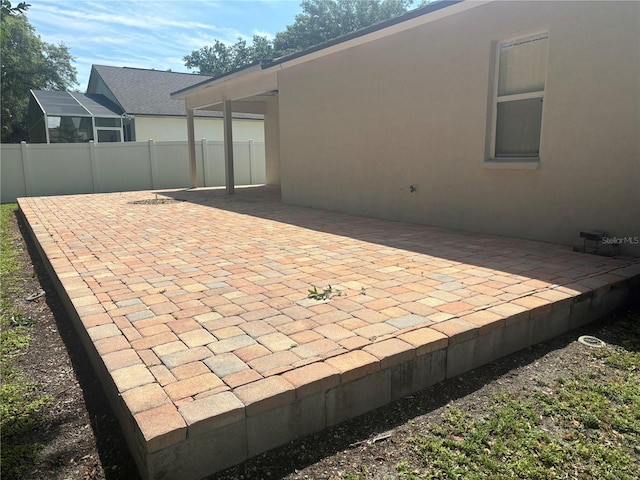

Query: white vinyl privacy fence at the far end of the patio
[[0, 139, 266, 203]]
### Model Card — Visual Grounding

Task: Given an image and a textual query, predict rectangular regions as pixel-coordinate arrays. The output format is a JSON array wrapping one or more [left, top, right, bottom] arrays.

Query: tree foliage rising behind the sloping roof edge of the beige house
[[183, 0, 413, 76]]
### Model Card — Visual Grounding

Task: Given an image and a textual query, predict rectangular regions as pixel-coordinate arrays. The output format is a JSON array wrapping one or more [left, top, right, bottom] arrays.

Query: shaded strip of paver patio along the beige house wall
[[157, 186, 637, 290]]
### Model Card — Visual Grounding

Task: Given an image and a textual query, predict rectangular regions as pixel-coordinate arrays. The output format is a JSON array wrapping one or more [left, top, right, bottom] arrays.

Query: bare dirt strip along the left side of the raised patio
[[9, 212, 139, 480]]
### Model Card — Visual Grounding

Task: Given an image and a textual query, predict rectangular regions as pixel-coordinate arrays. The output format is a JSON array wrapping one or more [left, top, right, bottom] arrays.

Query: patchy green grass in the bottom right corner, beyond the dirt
[[396, 318, 640, 480]]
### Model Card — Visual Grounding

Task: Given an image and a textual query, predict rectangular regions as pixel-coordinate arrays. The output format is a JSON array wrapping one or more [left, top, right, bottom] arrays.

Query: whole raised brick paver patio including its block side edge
[[19, 187, 640, 478]]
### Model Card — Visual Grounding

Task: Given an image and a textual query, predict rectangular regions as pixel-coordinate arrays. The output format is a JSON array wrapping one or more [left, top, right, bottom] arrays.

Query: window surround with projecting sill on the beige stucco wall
[[485, 30, 549, 164]]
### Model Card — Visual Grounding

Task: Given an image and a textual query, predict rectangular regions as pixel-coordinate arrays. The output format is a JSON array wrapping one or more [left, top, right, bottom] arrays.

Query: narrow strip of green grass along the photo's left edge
[[0, 204, 51, 479]]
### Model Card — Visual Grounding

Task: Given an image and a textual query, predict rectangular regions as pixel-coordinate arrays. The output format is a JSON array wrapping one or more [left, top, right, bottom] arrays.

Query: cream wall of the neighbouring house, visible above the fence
[[135, 115, 264, 142]]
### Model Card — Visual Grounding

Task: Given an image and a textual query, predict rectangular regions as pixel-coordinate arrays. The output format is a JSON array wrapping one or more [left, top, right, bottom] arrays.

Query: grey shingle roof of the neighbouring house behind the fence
[[87, 65, 263, 119]]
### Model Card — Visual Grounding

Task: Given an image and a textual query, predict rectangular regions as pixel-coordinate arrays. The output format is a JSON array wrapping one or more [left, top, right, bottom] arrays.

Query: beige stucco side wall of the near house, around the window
[[278, 1, 640, 255]]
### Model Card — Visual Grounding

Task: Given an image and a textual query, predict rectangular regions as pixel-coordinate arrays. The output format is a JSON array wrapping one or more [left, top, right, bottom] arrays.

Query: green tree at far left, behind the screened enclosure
[[0, 0, 78, 143]]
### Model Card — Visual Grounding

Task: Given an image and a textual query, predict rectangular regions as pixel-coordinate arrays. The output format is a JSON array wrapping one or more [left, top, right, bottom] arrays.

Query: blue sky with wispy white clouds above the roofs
[[26, 0, 301, 91]]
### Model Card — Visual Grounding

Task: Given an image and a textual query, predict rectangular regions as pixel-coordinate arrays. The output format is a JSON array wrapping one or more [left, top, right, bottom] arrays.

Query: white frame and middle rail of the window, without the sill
[[487, 29, 550, 164]]
